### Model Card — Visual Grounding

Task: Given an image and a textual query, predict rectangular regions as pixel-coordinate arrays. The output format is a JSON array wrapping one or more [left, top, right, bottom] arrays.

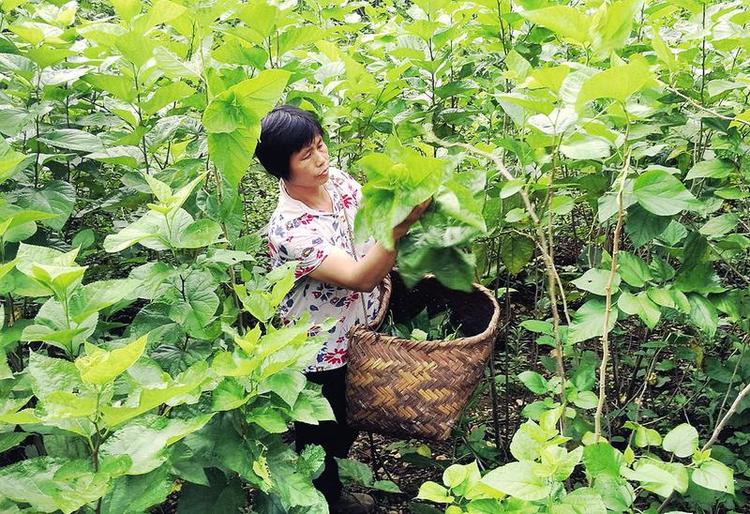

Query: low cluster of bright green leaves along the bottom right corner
[[418, 407, 733, 513]]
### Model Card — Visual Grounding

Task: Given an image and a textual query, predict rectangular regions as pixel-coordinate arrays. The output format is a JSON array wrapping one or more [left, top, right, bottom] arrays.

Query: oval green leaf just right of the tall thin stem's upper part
[[633, 170, 696, 216]]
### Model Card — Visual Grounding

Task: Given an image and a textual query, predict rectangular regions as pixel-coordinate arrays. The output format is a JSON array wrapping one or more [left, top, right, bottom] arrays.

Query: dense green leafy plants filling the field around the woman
[[0, 0, 750, 513]]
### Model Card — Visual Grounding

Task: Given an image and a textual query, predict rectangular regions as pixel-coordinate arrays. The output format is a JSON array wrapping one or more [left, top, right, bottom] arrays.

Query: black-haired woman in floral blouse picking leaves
[[255, 105, 429, 514]]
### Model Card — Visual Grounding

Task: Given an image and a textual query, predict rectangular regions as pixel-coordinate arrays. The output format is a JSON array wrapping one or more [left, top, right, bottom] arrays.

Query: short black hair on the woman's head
[[255, 105, 323, 179]]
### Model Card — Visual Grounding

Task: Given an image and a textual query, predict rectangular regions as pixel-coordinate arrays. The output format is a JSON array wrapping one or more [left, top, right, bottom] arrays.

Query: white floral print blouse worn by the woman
[[268, 167, 380, 372]]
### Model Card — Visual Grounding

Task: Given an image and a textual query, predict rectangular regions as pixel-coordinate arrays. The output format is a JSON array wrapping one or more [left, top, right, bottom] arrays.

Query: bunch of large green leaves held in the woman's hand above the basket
[[355, 138, 487, 291]]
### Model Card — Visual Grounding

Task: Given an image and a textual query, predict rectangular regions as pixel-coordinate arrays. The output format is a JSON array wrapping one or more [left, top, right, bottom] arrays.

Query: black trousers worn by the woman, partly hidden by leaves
[[294, 366, 358, 505]]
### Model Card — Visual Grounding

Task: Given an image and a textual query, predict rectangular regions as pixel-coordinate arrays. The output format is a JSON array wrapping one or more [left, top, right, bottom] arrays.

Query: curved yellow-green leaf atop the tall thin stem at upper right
[[576, 59, 652, 111]]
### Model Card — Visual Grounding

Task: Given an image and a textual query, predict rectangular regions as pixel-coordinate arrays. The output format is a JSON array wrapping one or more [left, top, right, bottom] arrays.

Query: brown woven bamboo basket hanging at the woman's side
[[346, 273, 500, 440]]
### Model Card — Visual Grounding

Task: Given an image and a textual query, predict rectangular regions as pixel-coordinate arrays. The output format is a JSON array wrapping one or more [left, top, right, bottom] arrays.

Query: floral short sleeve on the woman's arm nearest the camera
[[269, 227, 330, 279]]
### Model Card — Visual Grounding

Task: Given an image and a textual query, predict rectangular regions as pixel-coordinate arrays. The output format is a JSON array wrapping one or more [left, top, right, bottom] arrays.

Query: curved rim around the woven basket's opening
[[349, 274, 500, 349]]
